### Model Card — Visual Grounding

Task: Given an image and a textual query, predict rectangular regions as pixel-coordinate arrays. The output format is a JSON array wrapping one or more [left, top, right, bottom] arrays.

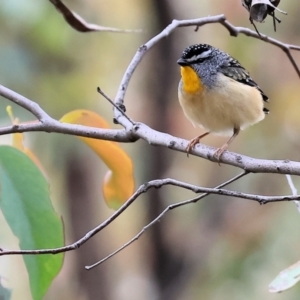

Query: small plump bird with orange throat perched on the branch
[[177, 44, 269, 160]]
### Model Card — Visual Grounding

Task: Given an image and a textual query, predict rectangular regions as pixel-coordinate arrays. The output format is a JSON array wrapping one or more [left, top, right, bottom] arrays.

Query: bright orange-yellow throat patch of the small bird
[[180, 66, 203, 94]]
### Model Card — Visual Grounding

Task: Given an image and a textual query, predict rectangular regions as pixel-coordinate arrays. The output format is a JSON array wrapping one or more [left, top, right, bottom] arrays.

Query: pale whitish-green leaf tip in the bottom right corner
[[269, 261, 300, 293]]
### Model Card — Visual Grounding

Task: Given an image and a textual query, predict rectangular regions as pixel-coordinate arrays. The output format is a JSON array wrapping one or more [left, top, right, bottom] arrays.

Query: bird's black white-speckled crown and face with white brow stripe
[[177, 44, 214, 66]]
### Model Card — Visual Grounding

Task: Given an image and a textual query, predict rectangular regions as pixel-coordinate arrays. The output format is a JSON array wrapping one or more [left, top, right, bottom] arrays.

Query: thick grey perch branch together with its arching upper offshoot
[[0, 15, 300, 171]]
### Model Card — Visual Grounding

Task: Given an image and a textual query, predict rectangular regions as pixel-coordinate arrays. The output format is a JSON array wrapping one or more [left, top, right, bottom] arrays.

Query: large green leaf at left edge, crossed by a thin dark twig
[[0, 146, 64, 300]]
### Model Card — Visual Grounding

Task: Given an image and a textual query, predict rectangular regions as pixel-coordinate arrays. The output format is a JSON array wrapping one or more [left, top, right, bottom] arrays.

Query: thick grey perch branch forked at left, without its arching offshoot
[[0, 85, 300, 175]]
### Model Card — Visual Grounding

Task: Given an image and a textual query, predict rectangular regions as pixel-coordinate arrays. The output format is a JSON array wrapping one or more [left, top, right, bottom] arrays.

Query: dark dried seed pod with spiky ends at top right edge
[[241, 0, 287, 35]]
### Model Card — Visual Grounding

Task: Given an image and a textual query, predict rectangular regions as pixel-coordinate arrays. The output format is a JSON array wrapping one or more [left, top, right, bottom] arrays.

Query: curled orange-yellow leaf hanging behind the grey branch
[[60, 109, 134, 209]]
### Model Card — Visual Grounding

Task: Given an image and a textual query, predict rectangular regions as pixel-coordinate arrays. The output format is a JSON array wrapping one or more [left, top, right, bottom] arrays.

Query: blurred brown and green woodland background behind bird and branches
[[0, 0, 300, 300]]
